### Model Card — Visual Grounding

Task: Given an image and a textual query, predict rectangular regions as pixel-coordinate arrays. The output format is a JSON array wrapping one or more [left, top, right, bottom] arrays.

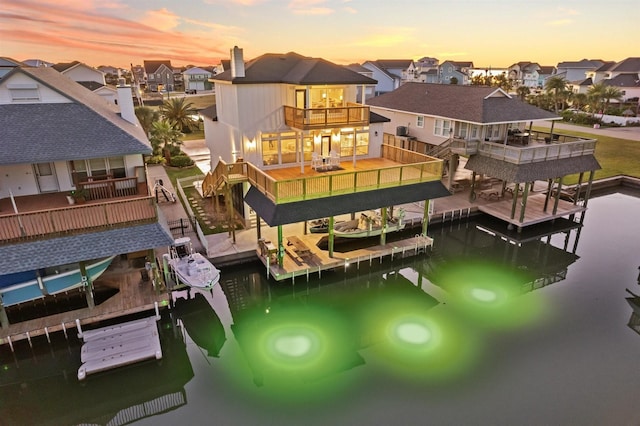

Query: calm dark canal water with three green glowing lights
[[0, 193, 640, 425]]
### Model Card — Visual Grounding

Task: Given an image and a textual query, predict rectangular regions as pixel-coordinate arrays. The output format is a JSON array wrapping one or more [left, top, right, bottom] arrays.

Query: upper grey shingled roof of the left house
[[0, 67, 151, 165]]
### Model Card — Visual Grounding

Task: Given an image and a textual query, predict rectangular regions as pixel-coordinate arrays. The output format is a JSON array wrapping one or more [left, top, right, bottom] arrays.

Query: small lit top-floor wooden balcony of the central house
[[284, 104, 369, 130]]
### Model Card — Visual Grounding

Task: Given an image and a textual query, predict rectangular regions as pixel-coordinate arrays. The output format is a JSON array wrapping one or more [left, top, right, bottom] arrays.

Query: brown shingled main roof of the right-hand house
[[367, 82, 561, 124]]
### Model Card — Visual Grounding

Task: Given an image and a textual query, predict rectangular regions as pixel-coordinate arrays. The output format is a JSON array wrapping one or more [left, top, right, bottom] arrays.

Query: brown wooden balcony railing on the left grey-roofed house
[[0, 197, 158, 244]]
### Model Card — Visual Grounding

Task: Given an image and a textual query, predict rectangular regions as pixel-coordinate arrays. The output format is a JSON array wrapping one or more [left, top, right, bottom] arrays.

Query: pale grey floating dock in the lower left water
[[78, 316, 162, 380]]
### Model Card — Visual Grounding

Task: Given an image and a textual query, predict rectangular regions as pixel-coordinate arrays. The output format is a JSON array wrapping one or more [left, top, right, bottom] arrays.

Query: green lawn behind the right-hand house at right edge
[[534, 128, 640, 185]]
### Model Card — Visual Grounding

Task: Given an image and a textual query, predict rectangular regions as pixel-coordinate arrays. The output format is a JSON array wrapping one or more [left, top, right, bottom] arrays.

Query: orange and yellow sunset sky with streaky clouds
[[0, 0, 640, 68]]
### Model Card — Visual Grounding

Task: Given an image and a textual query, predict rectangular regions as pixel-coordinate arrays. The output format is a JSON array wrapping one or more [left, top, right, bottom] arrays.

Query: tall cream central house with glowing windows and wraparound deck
[[203, 47, 448, 270]]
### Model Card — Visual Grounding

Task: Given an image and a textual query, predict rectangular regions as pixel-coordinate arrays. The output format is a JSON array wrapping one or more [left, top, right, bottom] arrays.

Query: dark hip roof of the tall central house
[[212, 52, 377, 85]]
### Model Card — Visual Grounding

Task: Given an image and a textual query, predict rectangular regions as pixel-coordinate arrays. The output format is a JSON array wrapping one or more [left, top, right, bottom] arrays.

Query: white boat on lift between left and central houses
[[163, 237, 220, 289]]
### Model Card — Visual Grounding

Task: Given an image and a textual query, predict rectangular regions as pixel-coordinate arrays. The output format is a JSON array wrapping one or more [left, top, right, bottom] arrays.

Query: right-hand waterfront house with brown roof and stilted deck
[[369, 83, 600, 228]]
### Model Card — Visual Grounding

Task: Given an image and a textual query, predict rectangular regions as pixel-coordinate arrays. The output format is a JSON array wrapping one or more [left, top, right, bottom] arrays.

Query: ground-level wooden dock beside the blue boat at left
[[0, 259, 169, 345]]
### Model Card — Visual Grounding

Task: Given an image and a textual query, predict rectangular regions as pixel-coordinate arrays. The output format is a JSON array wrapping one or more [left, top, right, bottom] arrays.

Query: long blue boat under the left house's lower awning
[[0, 256, 115, 306]]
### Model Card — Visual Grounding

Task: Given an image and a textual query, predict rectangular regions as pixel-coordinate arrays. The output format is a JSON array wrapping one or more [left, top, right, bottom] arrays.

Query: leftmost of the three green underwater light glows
[[229, 303, 363, 404]]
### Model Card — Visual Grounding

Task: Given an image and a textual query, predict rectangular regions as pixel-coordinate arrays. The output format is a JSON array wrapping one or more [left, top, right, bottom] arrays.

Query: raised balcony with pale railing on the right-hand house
[[450, 131, 596, 164]]
